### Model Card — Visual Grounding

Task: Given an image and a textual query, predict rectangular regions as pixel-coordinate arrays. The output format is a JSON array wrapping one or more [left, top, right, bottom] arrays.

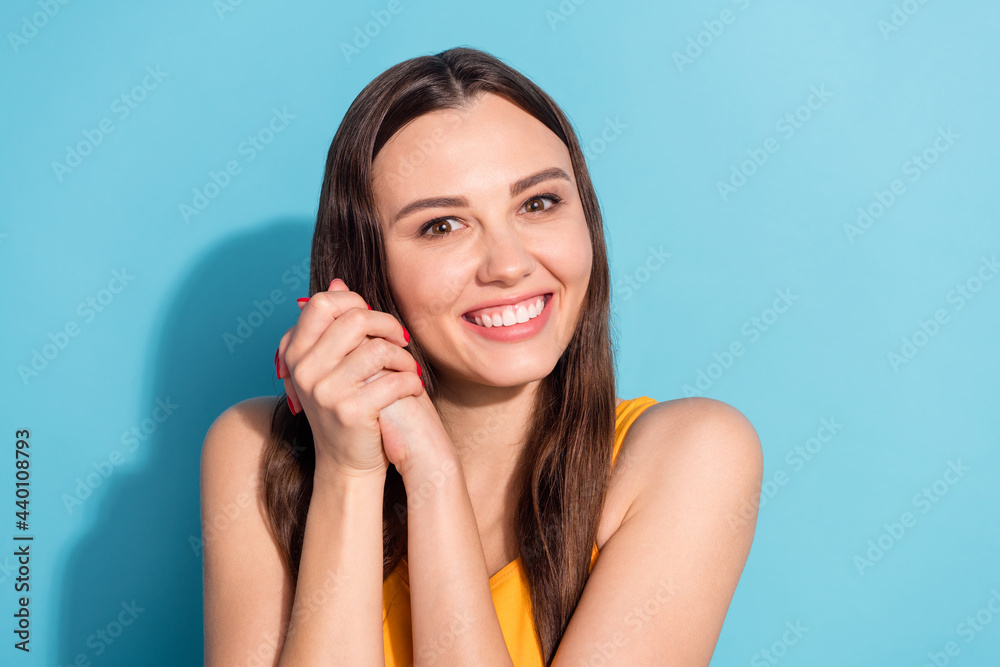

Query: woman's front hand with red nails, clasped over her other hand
[[276, 279, 430, 477]]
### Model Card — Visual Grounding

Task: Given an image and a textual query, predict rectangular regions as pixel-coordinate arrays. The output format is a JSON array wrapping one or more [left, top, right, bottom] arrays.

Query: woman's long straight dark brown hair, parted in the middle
[[262, 48, 615, 664]]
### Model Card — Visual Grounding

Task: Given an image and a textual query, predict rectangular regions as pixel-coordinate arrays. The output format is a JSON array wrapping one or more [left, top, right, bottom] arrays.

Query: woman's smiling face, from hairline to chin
[[373, 93, 593, 387]]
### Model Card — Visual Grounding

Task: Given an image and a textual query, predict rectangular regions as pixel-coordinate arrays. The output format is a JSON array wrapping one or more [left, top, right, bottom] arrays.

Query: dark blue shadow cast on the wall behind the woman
[[58, 219, 314, 667]]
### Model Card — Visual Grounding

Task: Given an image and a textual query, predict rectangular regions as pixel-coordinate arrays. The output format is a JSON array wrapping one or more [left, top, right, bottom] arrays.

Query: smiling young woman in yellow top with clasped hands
[[202, 48, 761, 667]]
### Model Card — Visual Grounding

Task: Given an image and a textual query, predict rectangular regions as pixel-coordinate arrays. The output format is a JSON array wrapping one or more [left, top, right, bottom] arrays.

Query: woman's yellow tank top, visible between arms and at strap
[[382, 396, 656, 667]]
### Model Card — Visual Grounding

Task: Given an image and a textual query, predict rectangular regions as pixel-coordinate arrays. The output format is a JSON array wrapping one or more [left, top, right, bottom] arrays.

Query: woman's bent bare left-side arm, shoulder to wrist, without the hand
[[201, 398, 385, 667]]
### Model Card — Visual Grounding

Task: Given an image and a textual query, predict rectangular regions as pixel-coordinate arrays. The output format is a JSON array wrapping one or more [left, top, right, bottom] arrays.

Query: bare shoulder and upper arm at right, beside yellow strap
[[552, 398, 763, 667]]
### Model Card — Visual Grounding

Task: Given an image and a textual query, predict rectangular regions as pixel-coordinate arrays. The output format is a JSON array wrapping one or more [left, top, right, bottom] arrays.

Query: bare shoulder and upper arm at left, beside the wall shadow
[[201, 397, 292, 665]]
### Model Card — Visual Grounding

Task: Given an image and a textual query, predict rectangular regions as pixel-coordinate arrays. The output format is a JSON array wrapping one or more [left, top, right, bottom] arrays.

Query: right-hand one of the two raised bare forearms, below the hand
[[400, 428, 513, 667]]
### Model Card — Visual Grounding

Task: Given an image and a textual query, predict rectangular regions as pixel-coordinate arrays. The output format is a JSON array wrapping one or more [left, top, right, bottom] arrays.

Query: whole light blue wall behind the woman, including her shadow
[[0, 0, 1000, 666]]
